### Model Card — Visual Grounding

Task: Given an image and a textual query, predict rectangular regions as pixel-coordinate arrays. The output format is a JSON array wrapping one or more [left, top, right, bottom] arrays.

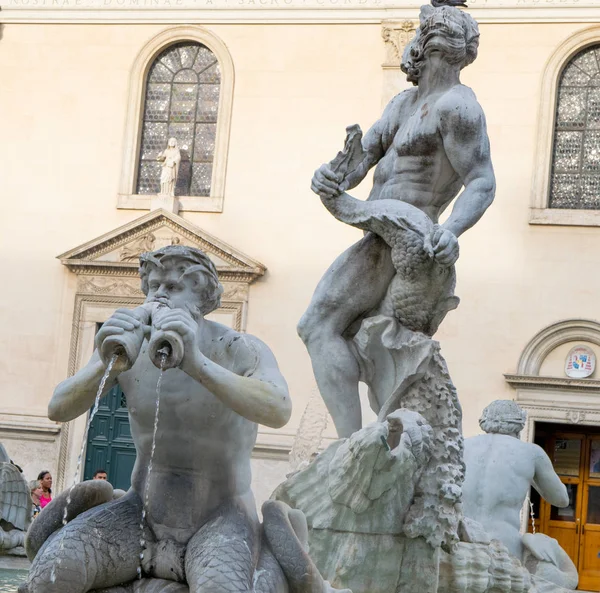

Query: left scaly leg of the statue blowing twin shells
[[26, 492, 142, 593]]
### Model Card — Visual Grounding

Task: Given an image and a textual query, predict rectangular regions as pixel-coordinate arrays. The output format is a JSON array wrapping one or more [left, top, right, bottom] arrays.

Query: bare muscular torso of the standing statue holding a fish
[[366, 84, 479, 222]]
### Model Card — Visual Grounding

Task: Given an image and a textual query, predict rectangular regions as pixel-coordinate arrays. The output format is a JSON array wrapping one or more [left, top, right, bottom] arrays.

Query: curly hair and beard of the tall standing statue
[[400, 5, 479, 84]]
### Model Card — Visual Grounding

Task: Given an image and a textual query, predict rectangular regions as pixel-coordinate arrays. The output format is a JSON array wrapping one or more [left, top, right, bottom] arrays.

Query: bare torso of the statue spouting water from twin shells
[[118, 320, 258, 544]]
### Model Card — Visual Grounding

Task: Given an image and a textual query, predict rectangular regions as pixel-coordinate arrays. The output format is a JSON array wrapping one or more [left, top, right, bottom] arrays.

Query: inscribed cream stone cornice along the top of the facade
[[0, 0, 600, 24]]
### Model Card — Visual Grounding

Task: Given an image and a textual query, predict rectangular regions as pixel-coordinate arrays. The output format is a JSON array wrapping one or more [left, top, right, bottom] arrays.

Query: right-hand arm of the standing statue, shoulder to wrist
[[440, 87, 496, 237]]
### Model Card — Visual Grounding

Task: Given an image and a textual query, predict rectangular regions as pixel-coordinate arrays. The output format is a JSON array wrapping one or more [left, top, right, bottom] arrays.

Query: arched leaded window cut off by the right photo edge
[[549, 45, 600, 210]]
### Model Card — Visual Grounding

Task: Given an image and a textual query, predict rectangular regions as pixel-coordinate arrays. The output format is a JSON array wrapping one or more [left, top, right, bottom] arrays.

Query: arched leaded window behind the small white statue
[[137, 42, 221, 196]]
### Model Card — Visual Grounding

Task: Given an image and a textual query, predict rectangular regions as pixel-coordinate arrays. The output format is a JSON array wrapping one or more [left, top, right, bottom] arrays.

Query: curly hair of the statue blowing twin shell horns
[[139, 245, 223, 316]]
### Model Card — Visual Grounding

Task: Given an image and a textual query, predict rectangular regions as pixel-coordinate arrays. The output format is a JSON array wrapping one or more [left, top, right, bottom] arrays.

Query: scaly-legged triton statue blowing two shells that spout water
[[19, 245, 349, 593]]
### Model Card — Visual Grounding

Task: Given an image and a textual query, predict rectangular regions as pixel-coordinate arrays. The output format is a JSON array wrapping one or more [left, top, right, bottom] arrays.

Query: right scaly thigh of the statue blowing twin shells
[[185, 501, 260, 593]]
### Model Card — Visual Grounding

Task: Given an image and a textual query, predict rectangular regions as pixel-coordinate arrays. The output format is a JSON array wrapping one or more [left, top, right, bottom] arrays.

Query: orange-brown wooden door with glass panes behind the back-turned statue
[[532, 425, 600, 591]]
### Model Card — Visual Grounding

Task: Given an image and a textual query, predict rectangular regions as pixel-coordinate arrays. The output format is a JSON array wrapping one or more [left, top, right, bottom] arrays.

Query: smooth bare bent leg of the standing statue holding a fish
[[298, 233, 396, 437]]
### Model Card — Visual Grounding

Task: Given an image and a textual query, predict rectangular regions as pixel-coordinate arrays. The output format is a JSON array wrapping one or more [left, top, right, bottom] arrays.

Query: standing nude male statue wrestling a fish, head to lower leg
[[298, 0, 495, 437]]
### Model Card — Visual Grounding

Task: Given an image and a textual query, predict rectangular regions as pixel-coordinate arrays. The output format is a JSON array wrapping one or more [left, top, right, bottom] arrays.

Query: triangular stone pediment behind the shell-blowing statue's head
[[58, 210, 266, 284]]
